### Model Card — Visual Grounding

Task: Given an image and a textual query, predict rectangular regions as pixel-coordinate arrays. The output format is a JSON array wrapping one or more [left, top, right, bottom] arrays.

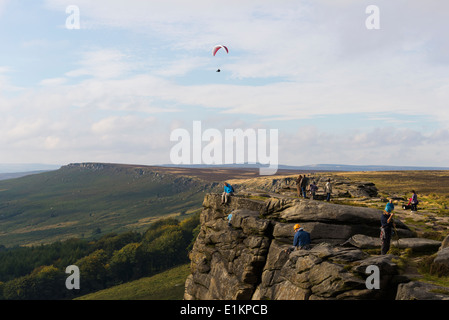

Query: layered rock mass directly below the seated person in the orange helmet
[[253, 241, 402, 300]]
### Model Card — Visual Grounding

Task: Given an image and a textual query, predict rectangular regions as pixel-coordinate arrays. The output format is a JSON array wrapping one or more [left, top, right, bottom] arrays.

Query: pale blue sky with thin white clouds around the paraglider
[[0, 0, 449, 170]]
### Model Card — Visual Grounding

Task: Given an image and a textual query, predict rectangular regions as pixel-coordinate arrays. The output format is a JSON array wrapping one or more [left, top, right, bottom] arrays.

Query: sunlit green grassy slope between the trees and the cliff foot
[[76, 264, 190, 300]]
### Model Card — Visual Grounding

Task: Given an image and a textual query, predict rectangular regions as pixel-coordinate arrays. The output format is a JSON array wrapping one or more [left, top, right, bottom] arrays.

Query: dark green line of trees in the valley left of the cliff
[[0, 213, 199, 300]]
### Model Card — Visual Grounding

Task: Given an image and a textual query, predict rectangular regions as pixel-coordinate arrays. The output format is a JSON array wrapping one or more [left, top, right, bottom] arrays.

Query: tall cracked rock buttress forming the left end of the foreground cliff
[[185, 206, 271, 300]]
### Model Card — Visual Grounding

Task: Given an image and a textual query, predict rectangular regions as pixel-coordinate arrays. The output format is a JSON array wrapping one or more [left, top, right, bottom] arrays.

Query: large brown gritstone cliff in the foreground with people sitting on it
[[184, 194, 440, 300]]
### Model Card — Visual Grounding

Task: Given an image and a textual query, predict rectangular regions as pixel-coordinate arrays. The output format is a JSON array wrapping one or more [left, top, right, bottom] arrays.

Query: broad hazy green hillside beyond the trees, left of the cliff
[[0, 164, 215, 247]]
